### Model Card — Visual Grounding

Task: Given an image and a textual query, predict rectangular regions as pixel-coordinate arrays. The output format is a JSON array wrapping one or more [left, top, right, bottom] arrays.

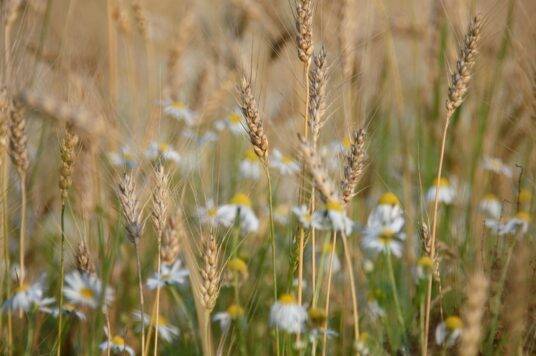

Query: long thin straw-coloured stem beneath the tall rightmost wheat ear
[[421, 111, 452, 356]]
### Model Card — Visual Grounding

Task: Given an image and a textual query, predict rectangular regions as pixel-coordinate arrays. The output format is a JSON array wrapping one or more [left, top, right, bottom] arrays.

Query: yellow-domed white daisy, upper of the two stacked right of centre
[[367, 192, 404, 233]]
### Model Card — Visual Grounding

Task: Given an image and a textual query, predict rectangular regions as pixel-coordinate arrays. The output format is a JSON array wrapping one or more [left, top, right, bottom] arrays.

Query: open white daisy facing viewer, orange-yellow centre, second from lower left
[[63, 270, 113, 308]]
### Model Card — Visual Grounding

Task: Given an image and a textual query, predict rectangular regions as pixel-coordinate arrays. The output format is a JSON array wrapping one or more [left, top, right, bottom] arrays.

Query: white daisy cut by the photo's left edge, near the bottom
[[2, 276, 54, 312]]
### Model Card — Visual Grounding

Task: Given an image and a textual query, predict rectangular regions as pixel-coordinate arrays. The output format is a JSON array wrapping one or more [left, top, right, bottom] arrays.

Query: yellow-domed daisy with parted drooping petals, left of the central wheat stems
[[216, 193, 259, 233]]
